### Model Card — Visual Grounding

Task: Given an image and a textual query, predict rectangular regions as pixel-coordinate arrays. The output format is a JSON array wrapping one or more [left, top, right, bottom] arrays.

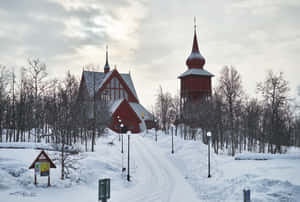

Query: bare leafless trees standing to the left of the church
[[0, 59, 110, 151]]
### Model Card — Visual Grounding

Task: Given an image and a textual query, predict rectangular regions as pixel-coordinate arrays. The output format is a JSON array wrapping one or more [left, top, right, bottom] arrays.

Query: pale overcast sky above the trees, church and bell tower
[[0, 0, 300, 108]]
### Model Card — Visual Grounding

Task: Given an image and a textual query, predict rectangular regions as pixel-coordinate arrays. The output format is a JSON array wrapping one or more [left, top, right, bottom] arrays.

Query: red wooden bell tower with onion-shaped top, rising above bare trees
[[178, 20, 214, 106]]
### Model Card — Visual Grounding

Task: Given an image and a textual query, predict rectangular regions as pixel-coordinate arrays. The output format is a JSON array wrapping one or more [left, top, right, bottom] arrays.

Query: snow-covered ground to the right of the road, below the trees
[[143, 132, 300, 202]]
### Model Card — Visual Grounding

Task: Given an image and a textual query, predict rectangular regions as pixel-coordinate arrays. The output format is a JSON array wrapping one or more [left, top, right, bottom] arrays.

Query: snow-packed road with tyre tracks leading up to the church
[[112, 135, 199, 202]]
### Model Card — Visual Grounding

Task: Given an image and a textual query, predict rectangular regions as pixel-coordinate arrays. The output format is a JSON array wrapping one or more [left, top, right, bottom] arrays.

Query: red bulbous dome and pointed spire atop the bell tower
[[186, 17, 205, 69]]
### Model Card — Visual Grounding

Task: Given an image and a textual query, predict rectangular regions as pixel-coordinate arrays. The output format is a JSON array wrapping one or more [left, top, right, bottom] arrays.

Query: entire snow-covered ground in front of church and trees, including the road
[[0, 131, 300, 202]]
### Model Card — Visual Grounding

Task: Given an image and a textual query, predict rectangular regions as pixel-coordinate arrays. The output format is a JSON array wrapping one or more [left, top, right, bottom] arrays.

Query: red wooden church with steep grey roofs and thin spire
[[79, 47, 153, 133]]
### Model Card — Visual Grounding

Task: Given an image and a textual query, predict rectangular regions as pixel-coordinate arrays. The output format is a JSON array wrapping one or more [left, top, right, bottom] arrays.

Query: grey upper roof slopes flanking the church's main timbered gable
[[83, 71, 138, 100]]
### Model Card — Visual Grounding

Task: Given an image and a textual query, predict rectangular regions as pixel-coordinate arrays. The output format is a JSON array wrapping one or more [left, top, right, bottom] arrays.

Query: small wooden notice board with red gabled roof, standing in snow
[[29, 151, 56, 187]]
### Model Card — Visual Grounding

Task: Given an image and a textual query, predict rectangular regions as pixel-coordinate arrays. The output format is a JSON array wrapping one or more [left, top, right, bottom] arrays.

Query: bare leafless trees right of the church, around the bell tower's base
[[154, 66, 300, 155]]
